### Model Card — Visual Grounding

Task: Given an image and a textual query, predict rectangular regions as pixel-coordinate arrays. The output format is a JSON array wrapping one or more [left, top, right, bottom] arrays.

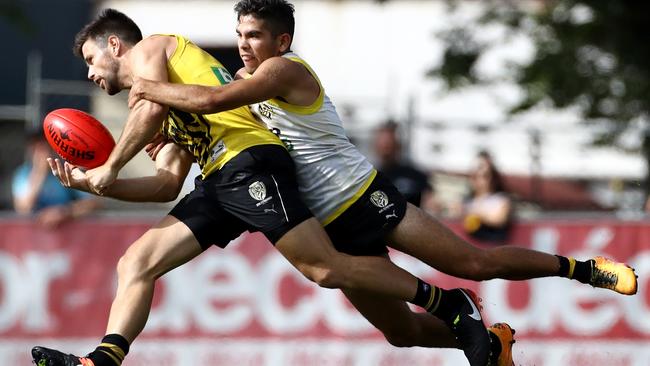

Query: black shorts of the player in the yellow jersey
[[169, 145, 313, 249]]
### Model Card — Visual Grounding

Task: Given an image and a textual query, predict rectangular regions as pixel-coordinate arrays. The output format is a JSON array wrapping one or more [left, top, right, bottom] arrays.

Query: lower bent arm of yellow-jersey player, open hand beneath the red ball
[[48, 143, 194, 202]]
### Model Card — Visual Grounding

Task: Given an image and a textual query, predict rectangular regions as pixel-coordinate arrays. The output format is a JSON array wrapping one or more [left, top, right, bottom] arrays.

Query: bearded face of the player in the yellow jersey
[[81, 39, 122, 95]]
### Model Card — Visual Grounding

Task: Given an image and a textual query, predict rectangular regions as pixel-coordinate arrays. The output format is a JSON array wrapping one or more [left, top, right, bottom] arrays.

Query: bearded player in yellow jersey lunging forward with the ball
[[32, 9, 486, 366]]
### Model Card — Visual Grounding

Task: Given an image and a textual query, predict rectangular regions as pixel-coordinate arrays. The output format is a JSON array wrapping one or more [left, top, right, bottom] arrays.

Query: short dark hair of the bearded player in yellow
[[72, 9, 142, 57]]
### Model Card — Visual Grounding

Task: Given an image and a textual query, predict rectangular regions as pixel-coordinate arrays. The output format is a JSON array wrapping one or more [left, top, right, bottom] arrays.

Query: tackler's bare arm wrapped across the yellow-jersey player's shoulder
[[129, 57, 305, 114]]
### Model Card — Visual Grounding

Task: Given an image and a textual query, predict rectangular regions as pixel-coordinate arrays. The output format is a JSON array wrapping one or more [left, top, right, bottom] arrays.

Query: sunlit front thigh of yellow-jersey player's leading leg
[[120, 215, 203, 277]]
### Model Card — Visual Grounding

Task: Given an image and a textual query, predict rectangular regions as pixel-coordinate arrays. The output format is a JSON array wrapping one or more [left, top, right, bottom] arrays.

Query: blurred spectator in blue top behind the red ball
[[12, 131, 101, 228]]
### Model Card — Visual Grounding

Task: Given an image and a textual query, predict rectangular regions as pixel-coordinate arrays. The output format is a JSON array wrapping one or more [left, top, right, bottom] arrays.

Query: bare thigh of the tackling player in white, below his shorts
[[388, 203, 485, 274]]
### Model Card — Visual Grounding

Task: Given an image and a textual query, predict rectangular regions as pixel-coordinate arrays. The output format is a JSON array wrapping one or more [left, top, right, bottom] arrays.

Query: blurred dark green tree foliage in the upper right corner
[[429, 0, 650, 190]]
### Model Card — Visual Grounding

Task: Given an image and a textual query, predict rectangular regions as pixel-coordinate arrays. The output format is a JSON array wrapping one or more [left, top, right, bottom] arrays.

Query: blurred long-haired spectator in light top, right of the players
[[461, 151, 513, 244]]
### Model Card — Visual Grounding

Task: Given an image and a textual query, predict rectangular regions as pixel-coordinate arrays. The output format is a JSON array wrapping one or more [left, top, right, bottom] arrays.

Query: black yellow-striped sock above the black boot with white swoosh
[[411, 278, 456, 322]]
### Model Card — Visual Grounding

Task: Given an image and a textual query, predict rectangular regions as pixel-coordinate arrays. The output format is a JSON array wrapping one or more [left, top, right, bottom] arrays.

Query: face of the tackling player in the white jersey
[[237, 15, 284, 74]]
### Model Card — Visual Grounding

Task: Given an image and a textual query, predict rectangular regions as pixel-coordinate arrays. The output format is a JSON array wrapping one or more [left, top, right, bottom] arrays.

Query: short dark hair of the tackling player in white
[[235, 0, 296, 39]]
